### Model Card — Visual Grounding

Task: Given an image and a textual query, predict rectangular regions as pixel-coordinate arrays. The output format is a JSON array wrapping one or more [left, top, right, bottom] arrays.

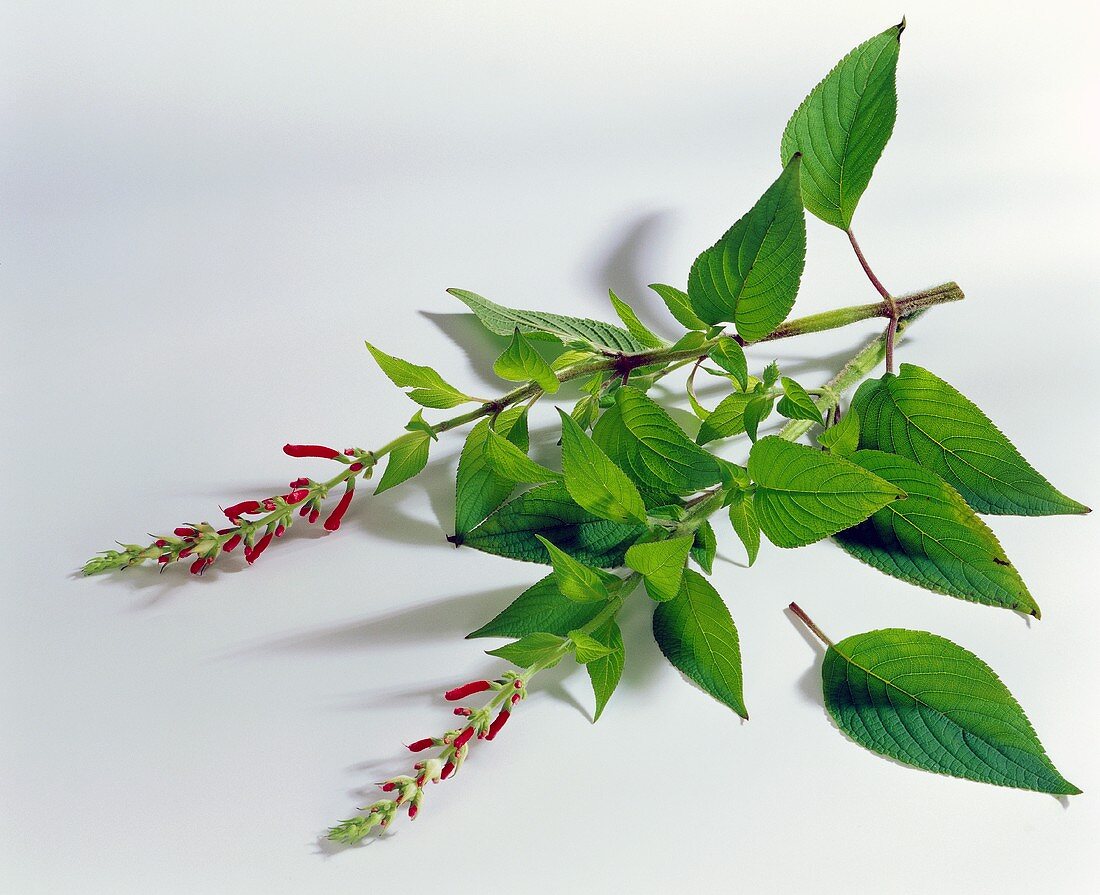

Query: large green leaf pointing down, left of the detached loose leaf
[[653, 568, 749, 718]]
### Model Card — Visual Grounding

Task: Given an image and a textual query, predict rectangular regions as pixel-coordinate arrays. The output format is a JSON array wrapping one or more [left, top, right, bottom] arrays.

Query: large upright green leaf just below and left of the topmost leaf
[[688, 155, 806, 342]]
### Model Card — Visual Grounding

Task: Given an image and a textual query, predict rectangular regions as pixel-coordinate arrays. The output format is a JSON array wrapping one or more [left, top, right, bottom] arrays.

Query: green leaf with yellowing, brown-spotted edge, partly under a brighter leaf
[[836, 451, 1040, 618]]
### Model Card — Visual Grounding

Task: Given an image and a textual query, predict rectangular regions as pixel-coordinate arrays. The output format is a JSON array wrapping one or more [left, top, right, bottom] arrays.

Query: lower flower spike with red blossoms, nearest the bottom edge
[[329, 672, 528, 846]]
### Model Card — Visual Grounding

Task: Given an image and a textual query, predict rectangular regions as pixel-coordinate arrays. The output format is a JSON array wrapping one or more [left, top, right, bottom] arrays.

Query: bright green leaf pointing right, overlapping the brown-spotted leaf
[[749, 435, 905, 546]]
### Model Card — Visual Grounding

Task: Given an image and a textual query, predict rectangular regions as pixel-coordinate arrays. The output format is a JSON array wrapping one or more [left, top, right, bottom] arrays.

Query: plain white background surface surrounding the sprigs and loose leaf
[[0, 0, 1100, 895]]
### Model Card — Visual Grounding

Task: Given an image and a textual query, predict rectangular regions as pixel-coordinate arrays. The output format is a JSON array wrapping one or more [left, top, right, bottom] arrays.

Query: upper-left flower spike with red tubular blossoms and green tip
[[84, 444, 375, 575]]
